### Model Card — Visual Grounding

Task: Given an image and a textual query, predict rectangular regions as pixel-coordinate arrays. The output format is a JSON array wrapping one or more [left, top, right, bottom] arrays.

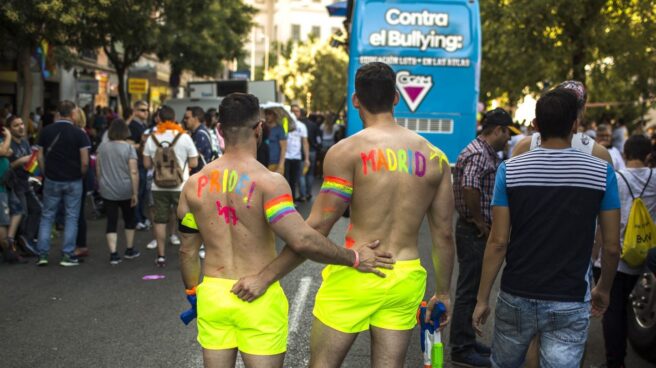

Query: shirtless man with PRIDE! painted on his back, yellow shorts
[[178, 93, 393, 368]]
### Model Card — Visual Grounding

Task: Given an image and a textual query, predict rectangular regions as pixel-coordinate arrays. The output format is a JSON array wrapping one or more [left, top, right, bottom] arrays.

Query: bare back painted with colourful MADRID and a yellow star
[[327, 125, 448, 260]]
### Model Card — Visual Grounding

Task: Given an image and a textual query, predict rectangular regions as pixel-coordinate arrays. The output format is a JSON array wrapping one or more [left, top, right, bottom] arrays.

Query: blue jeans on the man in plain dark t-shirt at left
[[37, 179, 82, 256]]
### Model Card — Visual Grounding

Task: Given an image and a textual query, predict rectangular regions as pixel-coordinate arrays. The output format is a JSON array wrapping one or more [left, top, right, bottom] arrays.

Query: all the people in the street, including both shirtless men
[[0, 63, 656, 367]]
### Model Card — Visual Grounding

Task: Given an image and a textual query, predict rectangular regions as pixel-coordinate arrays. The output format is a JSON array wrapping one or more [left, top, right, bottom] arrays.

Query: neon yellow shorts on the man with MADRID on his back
[[313, 259, 426, 333]]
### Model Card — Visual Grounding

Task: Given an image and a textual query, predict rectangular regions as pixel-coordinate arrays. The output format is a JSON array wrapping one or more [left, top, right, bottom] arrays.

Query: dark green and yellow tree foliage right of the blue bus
[[480, 0, 656, 123]]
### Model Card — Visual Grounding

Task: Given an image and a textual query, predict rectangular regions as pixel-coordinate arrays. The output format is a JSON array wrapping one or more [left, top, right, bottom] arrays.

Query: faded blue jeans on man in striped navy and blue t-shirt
[[491, 291, 590, 368]]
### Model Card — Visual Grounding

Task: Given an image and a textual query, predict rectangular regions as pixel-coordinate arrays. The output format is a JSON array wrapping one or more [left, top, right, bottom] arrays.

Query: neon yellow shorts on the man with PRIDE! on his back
[[196, 276, 289, 355]]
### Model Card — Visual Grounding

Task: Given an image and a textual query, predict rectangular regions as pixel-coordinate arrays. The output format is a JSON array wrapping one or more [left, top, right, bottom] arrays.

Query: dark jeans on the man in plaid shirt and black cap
[[450, 220, 487, 354]]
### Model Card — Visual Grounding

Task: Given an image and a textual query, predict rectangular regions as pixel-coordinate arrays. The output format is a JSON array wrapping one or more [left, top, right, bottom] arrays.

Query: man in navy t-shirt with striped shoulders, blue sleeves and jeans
[[472, 88, 620, 368]]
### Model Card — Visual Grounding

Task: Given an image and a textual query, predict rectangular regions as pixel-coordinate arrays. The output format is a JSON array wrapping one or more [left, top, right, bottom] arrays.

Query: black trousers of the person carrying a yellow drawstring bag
[[592, 267, 640, 368]]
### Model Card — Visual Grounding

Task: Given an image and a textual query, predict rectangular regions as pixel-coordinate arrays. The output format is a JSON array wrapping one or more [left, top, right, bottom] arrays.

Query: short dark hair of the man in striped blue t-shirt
[[535, 88, 578, 139]]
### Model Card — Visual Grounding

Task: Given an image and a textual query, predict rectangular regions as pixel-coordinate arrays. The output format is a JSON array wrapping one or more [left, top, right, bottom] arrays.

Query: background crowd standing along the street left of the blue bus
[[0, 100, 344, 266]]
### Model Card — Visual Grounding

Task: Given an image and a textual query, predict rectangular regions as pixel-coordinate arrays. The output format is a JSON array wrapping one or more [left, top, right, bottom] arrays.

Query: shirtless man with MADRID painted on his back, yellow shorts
[[235, 63, 454, 367]]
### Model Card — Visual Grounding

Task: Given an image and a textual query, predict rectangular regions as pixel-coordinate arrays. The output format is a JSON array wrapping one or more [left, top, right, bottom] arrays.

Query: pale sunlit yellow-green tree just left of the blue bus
[[265, 40, 348, 111]]
